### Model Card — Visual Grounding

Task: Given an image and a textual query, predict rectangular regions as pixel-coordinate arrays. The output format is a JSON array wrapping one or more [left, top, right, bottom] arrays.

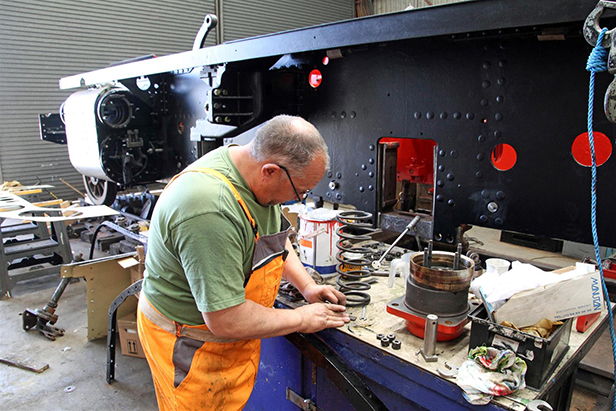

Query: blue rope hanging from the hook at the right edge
[[586, 28, 616, 411]]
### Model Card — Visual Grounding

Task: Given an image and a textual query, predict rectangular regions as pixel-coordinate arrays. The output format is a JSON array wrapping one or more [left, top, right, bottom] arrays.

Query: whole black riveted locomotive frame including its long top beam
[[55, 0, 616, 245]]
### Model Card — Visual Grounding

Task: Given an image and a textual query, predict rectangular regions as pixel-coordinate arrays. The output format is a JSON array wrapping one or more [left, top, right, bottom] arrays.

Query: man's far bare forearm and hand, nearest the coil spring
[[282, 239, 346, 305]]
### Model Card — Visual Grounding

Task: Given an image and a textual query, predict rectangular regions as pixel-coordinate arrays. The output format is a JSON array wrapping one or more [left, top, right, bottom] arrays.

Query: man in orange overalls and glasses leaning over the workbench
[[138, 115, 349, 410]]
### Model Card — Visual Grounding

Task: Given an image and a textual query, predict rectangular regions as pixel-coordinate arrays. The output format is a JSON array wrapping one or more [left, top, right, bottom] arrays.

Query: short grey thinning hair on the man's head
[[250, 114, 329, 172]]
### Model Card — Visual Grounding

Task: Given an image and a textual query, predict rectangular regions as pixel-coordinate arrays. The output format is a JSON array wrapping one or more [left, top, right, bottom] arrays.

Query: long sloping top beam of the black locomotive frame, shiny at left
[[60, 0, 613, 89]]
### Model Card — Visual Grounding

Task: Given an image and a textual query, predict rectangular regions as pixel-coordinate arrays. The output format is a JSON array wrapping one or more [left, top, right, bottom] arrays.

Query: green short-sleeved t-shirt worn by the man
[[143, 147, 281, 325]]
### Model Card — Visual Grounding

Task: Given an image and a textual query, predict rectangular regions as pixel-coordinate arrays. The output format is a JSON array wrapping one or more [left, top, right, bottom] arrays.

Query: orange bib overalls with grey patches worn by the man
[[137, 168, 290, 411]]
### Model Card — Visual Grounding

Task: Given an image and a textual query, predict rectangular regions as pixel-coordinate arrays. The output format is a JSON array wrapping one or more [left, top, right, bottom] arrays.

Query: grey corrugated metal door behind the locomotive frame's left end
[[0, 0, 214, 199]]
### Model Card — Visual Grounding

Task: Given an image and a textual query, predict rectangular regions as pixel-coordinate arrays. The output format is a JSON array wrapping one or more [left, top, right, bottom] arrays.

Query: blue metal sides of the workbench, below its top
[[246, 330, 502, 411]]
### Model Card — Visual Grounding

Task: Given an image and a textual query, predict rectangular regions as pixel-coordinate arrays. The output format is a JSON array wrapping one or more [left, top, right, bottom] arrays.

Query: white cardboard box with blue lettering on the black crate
[[494, 267, 604, 328]]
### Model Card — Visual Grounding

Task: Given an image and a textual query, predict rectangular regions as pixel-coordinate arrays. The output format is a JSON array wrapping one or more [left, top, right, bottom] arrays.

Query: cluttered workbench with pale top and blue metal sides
[[246, 277, 611, 411]]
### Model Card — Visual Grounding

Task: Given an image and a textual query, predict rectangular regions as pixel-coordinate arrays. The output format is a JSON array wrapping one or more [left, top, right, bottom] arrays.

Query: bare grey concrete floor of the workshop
[[0, 237, 611, 411]]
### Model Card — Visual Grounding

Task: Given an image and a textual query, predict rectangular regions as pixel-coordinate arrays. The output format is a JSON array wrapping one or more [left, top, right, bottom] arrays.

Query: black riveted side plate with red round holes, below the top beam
[[305, 25, 616, 248]]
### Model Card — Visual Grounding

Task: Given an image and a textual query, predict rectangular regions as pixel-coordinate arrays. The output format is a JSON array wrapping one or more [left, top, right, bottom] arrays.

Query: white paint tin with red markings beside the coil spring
[[298, 208, 341, 277]]
